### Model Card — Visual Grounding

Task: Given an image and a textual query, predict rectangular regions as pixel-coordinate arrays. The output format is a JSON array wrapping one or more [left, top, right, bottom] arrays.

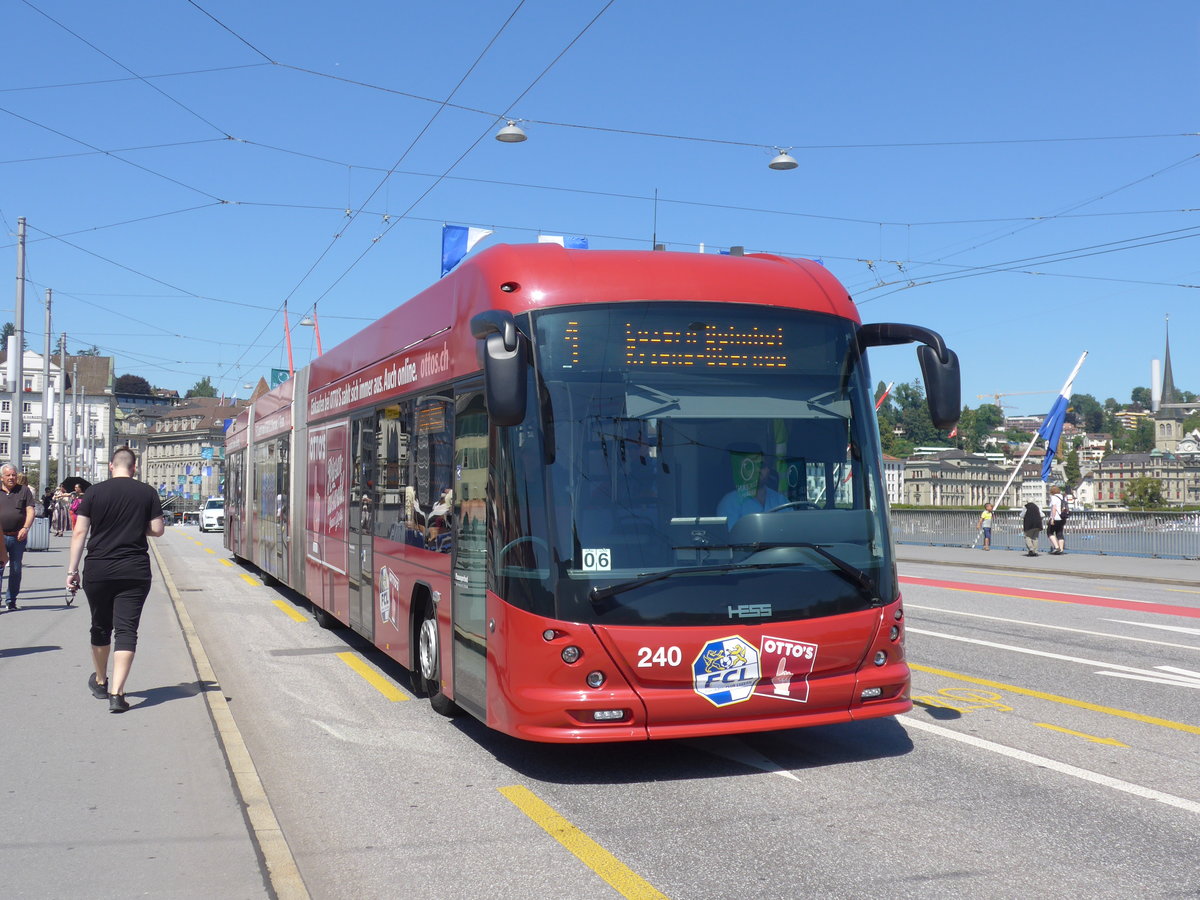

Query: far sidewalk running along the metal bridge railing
[[896, 544, 1200, 587]]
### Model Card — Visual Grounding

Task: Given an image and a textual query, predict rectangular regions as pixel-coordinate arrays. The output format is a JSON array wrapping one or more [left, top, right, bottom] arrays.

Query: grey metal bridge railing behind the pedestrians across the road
[[892, 509, 1200, 559]]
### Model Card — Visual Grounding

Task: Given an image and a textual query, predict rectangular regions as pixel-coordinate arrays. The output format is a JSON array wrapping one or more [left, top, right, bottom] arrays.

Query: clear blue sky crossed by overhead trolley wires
[[0, 0, 1200, 413]]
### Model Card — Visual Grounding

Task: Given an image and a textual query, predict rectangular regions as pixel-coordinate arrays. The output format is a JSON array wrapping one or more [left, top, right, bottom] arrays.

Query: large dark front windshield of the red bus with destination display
[[493, 301, 895, 625]]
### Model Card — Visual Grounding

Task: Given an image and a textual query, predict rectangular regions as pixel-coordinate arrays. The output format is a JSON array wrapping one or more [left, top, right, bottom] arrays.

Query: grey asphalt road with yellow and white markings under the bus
[[157, 527, 1200, 900]]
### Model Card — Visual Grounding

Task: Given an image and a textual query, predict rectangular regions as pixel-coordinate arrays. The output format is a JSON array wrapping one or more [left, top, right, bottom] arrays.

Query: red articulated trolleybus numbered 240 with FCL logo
[[224, 244, 959, 743]]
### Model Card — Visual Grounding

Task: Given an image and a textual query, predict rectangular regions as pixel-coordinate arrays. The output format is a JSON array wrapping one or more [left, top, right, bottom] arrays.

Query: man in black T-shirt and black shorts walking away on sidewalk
[[67, 446, 163, 713]]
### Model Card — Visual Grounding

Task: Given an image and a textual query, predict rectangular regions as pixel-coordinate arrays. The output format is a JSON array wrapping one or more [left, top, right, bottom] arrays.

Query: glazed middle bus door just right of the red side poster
[[346, 414, 377, 641]]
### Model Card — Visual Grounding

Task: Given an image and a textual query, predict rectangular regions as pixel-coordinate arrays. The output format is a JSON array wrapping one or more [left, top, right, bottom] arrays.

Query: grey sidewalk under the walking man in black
[[0, 535, 270, 898]]
